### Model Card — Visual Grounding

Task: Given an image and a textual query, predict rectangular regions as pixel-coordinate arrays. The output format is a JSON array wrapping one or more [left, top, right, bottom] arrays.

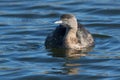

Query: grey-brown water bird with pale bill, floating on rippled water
[[45, 14, 94, 50]]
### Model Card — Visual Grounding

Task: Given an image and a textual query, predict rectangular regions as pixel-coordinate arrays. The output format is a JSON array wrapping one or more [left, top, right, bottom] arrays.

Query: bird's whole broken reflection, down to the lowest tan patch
[[49, 47, 92, 75]]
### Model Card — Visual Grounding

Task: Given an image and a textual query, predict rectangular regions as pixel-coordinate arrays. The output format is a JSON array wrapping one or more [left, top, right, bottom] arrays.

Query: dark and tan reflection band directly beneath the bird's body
[[49, 47, 93, 59]]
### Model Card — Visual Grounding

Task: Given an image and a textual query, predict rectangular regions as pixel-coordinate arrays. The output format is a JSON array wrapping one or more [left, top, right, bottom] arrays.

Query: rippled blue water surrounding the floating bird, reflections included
[[0, 0, 120, 80]]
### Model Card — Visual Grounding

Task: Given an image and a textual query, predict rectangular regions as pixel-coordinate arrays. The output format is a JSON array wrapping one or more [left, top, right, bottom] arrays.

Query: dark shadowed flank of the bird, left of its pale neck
[[45, 25, 66, 48]]
